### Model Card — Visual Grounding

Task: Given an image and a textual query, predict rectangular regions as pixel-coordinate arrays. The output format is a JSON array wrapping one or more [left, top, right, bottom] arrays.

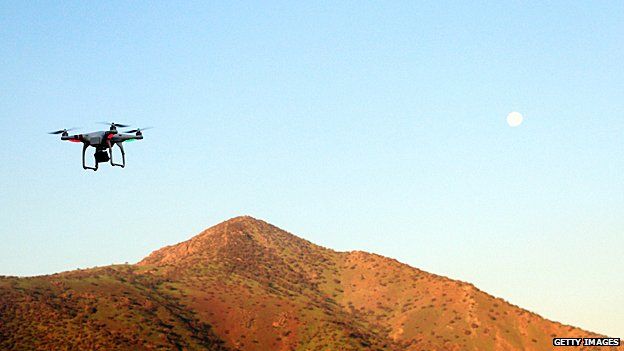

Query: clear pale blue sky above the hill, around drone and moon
[[0, 1, 624, 337]]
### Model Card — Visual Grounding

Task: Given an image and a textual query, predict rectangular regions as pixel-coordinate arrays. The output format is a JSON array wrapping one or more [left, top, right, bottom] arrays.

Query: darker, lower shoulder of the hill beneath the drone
[[0, 266, 227, 351]]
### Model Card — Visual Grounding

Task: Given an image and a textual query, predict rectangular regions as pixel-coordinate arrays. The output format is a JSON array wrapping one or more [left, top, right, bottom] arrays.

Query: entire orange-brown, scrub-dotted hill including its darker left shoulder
[[0, 217, 622, 350]]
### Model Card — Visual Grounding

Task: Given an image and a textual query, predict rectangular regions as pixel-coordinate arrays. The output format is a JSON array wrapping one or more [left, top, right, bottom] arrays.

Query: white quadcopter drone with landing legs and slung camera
[[49, 122, 151, 171]]
